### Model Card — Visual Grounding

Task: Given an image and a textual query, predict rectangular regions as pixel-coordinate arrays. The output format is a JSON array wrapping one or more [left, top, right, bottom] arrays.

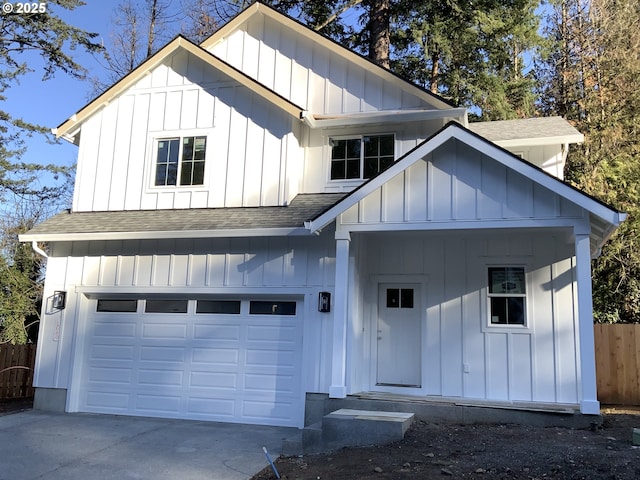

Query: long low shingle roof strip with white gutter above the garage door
[[20, 193, 345, 242]]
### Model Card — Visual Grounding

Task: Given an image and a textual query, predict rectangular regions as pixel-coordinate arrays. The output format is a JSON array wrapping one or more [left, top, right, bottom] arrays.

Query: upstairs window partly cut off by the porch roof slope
[[330, 135, 395, 180]]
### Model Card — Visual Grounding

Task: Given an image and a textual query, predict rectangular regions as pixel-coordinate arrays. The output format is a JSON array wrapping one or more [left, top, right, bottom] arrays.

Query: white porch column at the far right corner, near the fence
[[574, 228, 600, 415]]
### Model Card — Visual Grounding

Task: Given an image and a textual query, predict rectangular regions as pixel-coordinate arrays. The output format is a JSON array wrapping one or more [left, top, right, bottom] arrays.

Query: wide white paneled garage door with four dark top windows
[[79, 299, 303, 426]]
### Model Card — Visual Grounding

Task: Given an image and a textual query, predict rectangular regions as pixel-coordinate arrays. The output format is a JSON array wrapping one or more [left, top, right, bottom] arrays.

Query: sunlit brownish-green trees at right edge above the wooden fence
[[541, 0, 640, 323]]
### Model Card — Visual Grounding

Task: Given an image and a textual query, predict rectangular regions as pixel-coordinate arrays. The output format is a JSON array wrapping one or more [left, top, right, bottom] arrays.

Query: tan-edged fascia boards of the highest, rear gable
[[200, 1, 456, 109]]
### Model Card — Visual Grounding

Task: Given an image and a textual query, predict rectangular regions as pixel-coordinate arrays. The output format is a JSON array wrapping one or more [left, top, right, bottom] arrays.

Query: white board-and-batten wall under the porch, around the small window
[[360, 231, 579, 404]]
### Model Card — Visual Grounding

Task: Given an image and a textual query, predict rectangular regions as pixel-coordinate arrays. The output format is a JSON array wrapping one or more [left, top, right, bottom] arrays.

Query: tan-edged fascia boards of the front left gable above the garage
[[52, 35, 304, 143]]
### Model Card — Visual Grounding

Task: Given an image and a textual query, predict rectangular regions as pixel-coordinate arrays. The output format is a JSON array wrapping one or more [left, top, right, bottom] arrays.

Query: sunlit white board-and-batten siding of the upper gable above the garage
[[73, 51, 303, 211]]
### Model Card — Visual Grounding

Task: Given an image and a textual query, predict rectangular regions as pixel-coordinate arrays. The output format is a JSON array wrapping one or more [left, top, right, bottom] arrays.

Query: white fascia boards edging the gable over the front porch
[[305, 122, 626, 247]]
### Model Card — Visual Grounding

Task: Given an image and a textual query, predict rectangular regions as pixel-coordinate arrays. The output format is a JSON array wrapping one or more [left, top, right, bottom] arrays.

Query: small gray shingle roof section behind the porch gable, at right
[[469, 117, 580, 142]]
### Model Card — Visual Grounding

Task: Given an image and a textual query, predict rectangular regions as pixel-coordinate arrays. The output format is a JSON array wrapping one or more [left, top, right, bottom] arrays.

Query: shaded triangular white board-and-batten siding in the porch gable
[[340, 140, 584, 230]]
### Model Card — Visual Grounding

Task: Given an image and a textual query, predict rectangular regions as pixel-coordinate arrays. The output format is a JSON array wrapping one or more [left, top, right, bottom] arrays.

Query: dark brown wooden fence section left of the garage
[[0, 343, 36, 399]]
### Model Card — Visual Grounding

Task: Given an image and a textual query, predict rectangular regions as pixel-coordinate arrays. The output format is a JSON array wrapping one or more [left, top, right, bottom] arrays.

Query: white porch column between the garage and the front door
[[329, 231, 351, 398]]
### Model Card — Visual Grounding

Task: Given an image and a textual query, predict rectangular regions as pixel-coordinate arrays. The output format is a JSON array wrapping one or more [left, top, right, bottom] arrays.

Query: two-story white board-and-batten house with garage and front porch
[[21, 3, 625, 427]]
